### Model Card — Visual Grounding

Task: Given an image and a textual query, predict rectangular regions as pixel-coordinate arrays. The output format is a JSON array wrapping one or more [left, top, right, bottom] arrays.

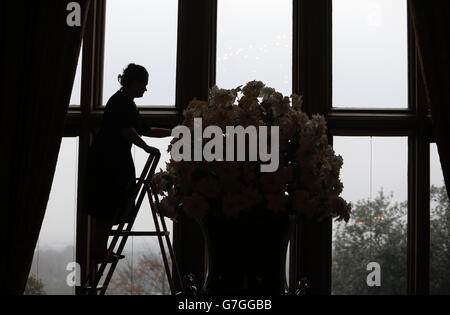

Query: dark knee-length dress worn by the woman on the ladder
[[84, 90, 150, 224]]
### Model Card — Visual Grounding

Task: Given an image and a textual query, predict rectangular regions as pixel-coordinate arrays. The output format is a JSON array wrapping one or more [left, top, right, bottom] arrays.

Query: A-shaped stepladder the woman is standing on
[[82, 152, 184, 295]]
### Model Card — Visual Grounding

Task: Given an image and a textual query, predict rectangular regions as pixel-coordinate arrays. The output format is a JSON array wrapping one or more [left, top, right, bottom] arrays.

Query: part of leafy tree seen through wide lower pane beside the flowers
[[333, 190, 407, 295]]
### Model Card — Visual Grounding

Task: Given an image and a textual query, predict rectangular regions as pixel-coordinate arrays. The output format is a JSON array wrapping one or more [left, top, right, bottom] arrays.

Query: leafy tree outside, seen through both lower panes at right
[[332, 186, 450, 295]]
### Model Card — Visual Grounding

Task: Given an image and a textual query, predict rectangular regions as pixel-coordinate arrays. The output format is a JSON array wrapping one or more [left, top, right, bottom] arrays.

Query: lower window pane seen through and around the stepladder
[[108, 137, 173, 295]]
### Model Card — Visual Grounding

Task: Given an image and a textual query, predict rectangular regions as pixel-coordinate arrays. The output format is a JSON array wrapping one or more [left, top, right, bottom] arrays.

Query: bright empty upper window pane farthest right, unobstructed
[[333, 0, 408, 108]]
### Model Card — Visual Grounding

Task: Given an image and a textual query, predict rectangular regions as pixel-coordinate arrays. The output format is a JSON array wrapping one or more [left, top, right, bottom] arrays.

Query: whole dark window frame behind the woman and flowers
[[64, 0, 433, 294]]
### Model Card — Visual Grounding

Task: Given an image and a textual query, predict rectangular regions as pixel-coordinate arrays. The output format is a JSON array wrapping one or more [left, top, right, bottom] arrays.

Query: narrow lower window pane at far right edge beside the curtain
[[430, 144, 450, 295]]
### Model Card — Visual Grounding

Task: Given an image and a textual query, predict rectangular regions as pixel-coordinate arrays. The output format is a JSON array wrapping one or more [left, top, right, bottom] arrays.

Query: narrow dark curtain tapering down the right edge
[[409, 0, 450, 195]]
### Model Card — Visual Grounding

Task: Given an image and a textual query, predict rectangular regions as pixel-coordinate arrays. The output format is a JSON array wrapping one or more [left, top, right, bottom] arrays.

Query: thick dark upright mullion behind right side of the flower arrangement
[[291, 0, 332, 294]]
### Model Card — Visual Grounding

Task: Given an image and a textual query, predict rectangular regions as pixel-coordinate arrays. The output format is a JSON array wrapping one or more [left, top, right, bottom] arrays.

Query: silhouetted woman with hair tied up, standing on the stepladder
[[85, 64, 171, 260]]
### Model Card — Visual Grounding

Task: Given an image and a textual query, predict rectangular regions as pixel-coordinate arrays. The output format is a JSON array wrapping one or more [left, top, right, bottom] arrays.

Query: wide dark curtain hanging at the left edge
[[0, 0, 89, 295]]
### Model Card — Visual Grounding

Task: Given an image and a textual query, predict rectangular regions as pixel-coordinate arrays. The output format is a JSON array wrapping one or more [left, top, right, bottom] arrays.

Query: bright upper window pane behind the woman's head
[[103, 0, 178, 106]]
